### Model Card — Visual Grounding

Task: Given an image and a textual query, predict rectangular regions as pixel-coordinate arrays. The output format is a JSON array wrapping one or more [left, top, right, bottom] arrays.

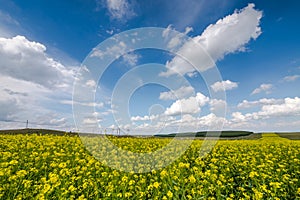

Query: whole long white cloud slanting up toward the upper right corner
[[160, 4, 262, 76]]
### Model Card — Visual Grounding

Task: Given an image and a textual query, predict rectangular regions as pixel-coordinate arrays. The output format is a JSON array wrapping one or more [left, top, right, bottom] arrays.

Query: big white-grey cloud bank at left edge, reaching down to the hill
[[0, 36, 76, 129]]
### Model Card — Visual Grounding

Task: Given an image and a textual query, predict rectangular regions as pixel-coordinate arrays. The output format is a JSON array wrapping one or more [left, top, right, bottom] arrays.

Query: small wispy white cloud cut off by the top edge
[[106, 0, 135, 21]]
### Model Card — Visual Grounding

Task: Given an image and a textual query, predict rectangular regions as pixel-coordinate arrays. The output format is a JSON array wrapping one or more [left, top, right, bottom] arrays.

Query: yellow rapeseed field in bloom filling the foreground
[[0, 133, 300, 199]]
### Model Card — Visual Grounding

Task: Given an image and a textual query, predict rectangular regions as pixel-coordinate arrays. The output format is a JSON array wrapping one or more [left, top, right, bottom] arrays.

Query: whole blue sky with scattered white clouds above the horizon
[[0, 0, 300, 134]]
